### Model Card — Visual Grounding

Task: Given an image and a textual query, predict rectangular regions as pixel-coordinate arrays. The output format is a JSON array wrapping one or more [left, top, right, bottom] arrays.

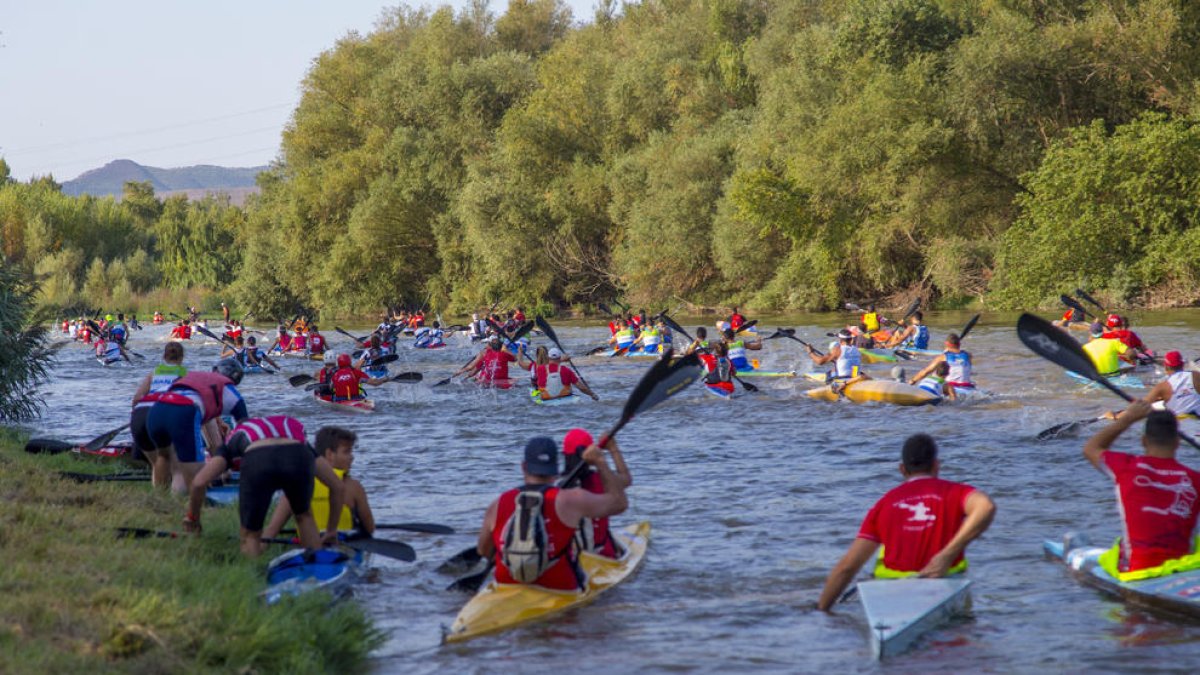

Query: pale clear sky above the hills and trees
[[0, 0, 594, 183]]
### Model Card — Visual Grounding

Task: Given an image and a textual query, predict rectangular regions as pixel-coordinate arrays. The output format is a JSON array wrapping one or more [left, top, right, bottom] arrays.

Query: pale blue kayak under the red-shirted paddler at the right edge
[[1042, 534, 1200, 620]]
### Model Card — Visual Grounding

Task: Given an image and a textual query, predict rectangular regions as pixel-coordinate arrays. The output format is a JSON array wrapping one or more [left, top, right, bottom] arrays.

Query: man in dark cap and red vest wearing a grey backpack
[[476, 436, 629, 591]]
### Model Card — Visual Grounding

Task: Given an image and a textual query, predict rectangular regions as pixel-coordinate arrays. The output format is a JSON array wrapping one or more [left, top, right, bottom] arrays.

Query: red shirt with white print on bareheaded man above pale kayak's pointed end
[[858, 476, 974, 572]]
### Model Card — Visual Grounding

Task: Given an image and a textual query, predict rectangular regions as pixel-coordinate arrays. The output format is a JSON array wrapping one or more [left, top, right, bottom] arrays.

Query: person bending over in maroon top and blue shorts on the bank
[[131, 359, 248, 491]]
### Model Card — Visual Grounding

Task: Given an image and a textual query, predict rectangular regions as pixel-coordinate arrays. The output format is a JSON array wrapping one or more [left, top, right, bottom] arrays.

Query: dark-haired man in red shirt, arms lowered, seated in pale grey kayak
[[817, 434, 996, 611]]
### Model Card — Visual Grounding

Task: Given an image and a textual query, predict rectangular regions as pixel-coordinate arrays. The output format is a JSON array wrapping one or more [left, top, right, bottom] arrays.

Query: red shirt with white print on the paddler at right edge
[[1100, 450, 1200, 572]]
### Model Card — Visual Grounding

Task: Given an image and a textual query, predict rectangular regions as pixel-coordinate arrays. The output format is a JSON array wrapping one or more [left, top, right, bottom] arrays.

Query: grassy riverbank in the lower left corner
[[0, 430, 380, 673]]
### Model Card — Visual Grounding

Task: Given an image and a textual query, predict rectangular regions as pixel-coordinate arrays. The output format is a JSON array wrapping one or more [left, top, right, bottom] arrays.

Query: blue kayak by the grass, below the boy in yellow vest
[[263, 546, 367, 604]]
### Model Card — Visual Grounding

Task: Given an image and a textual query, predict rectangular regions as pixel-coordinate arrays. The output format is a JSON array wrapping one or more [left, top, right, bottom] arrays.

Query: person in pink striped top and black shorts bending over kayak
[[184, 416, 344, 557]]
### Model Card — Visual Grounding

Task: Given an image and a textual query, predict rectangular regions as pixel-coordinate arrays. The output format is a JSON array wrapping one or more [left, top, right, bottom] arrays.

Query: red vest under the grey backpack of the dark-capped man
[[492, 485, 584, 591]]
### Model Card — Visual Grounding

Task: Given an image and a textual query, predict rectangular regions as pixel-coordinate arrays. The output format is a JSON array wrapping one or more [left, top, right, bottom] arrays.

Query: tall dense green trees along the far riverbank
[[0, 0, 1200, 316]]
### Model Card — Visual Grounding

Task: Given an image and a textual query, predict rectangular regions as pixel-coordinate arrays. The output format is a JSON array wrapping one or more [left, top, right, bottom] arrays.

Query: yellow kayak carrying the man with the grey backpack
[[445, 522, 650, 643]]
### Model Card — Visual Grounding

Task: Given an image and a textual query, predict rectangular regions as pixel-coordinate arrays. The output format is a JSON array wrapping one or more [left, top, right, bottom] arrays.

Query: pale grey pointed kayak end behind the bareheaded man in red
[[858, 577, 971, 659]]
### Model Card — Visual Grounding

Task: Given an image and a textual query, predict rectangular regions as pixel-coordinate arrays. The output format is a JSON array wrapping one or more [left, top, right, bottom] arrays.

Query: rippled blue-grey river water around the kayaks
[[16, 312, 1200, 673]]
